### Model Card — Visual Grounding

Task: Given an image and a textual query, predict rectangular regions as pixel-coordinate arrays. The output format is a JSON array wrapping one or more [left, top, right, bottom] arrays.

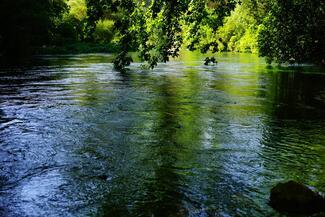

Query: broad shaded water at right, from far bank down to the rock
[[260, 68, 325, 192]]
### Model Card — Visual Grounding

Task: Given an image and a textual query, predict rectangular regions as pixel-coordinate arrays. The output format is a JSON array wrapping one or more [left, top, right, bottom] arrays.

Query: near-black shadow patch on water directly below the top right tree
[[264, 69, 325, 119]]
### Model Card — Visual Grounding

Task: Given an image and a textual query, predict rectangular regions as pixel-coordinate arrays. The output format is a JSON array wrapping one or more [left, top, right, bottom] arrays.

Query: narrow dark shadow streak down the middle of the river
[[97, 74, 185, 216]]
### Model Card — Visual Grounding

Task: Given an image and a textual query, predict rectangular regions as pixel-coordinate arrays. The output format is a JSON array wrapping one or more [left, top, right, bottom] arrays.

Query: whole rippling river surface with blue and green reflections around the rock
[[0, 53, 325, 217]]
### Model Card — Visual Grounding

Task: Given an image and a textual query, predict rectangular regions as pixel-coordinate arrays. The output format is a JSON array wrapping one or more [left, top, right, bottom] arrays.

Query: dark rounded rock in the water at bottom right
[[270, 181, 325, 214]]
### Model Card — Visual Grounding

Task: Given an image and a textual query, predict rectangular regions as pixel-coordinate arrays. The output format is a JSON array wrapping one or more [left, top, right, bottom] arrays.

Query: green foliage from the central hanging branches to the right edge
[[87, 0, 325, 69]]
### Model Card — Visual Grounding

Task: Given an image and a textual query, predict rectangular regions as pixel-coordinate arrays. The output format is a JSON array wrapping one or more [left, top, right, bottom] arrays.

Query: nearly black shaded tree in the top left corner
[[0, 0, 67, 63]]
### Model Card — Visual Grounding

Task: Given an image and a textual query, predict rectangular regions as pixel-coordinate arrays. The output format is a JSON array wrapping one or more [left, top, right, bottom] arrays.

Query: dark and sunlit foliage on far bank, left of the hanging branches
[[0, 0, 118, 62]]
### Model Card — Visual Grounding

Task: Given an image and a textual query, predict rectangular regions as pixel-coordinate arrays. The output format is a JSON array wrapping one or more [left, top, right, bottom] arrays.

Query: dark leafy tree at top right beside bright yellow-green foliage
[[258, 0, 325, 63]]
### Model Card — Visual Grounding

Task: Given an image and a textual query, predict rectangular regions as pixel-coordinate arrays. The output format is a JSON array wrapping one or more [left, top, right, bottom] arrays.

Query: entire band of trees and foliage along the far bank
[[0, 0, 325, 69]]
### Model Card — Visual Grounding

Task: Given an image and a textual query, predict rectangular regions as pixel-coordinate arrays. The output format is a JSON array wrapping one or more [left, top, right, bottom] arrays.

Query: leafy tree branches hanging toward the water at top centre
[[87, 0, 235, 70]]
